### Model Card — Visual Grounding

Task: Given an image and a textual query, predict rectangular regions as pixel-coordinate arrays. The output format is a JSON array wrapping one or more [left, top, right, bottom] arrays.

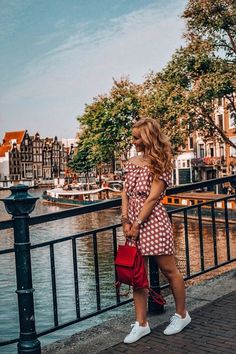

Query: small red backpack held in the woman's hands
[[114, 242, 166, 305]]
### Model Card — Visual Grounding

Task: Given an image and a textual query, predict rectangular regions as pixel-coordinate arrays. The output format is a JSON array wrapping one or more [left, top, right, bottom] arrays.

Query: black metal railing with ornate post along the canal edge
[[0, 176, 236, 353]]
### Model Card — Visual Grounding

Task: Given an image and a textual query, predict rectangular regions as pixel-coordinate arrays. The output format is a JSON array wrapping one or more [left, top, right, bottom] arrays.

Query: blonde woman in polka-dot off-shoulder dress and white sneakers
[[121, 118, 191, 343]]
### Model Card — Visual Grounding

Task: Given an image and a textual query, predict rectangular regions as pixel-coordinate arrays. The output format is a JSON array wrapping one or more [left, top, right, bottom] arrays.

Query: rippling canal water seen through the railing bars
[[0, 189, 236, 354]]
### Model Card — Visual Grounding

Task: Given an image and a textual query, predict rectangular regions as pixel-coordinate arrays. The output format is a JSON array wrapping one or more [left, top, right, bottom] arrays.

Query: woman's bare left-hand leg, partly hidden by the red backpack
[[133, 257, 148, 326]]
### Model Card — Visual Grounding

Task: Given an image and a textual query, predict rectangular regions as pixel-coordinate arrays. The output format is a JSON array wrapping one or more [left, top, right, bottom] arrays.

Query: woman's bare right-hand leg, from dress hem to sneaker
[[156, 255, 186, 318]]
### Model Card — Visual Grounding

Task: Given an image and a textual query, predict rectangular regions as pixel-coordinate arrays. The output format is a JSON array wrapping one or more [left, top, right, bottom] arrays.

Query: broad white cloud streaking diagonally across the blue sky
[[0, 0, 187, 136]]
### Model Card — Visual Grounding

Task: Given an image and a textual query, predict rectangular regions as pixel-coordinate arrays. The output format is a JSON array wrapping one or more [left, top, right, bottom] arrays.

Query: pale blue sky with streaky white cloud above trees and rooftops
[[0, 0, 187, 141]]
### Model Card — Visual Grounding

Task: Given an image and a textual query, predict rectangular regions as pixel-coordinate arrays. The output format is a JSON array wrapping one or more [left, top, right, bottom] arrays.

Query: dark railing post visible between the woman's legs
[[148, 256, 164, 314]]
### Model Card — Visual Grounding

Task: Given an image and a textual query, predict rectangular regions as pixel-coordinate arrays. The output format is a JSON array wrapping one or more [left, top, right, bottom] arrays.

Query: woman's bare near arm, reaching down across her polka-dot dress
[[128, 179, 165, 238]]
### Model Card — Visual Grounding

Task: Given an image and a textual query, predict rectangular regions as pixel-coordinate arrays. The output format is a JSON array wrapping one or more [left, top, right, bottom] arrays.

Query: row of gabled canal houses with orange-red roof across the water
[[0, 130, 74, 186]]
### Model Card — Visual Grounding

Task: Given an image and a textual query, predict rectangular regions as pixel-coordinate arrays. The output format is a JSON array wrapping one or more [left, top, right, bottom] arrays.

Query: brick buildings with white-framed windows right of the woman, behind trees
[[174, 98, 236, 185]]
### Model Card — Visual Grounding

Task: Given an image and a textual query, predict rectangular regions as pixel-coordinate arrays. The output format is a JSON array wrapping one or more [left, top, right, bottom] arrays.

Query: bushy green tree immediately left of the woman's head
[[78, 78, 140, 169]]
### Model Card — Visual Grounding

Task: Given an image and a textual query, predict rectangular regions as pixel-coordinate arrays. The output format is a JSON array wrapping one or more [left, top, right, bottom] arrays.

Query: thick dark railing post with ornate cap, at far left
[[2, 184, 41, 354]]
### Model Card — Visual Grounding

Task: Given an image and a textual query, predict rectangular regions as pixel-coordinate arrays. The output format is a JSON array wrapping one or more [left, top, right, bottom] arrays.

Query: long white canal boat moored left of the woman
[[42, 187, 121, 206]]
